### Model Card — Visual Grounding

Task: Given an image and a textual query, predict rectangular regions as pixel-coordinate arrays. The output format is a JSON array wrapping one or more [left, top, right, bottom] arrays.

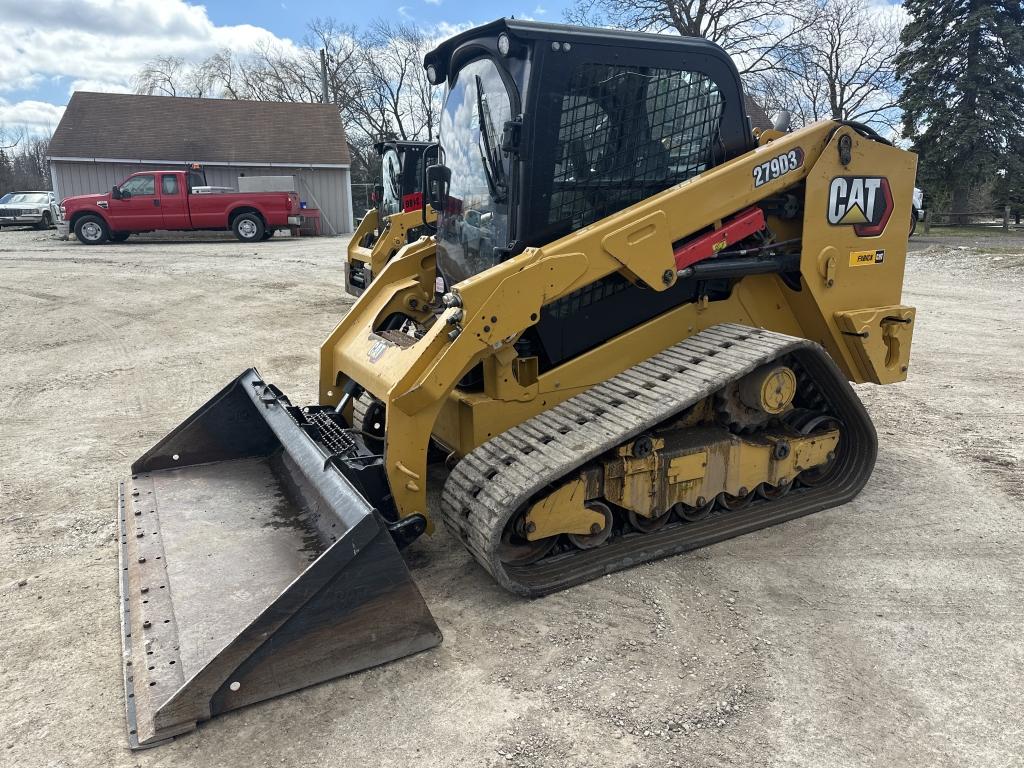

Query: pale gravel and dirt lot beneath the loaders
[[0, 230, 1024, 768]]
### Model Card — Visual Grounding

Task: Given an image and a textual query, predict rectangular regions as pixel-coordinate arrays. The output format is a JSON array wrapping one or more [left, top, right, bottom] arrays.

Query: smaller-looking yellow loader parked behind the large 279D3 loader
[[345, 139, 437, 296]]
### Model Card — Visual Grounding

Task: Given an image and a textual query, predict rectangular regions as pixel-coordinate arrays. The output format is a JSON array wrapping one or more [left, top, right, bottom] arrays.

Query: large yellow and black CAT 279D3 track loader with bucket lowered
[[120, 19, 915, 746]]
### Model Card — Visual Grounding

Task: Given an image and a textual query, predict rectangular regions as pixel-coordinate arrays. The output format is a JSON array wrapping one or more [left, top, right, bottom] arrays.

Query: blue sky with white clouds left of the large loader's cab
[[0, 0, 571, 133]]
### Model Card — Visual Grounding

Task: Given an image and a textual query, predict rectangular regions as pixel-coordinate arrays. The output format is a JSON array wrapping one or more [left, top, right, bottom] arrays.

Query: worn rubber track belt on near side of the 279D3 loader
[[441, 324, 878, 596]]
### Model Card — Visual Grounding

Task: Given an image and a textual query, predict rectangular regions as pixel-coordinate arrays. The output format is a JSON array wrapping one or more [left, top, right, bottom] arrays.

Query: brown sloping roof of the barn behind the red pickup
[[49, 91, 351, 166]]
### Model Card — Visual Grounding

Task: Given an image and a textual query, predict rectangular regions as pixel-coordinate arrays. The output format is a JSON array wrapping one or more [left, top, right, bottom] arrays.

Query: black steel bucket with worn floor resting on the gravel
[[118, 369, 441, 749]]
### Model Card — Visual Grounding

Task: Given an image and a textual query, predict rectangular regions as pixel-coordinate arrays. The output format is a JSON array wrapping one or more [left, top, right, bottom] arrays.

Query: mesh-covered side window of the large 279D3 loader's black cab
[[548, 63, 722, 229]]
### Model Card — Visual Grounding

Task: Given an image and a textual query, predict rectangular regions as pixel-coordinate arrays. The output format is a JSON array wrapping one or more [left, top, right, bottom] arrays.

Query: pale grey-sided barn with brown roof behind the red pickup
[[49, 91, 354, 234]]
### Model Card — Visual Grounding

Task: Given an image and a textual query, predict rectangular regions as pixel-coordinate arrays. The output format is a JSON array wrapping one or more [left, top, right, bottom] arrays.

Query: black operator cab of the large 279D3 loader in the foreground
[[424, 18, 754, 285]]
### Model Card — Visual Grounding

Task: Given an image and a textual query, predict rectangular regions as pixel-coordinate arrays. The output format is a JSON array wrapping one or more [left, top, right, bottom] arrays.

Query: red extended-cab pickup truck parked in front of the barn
[[60, 171, 300, 246]]
